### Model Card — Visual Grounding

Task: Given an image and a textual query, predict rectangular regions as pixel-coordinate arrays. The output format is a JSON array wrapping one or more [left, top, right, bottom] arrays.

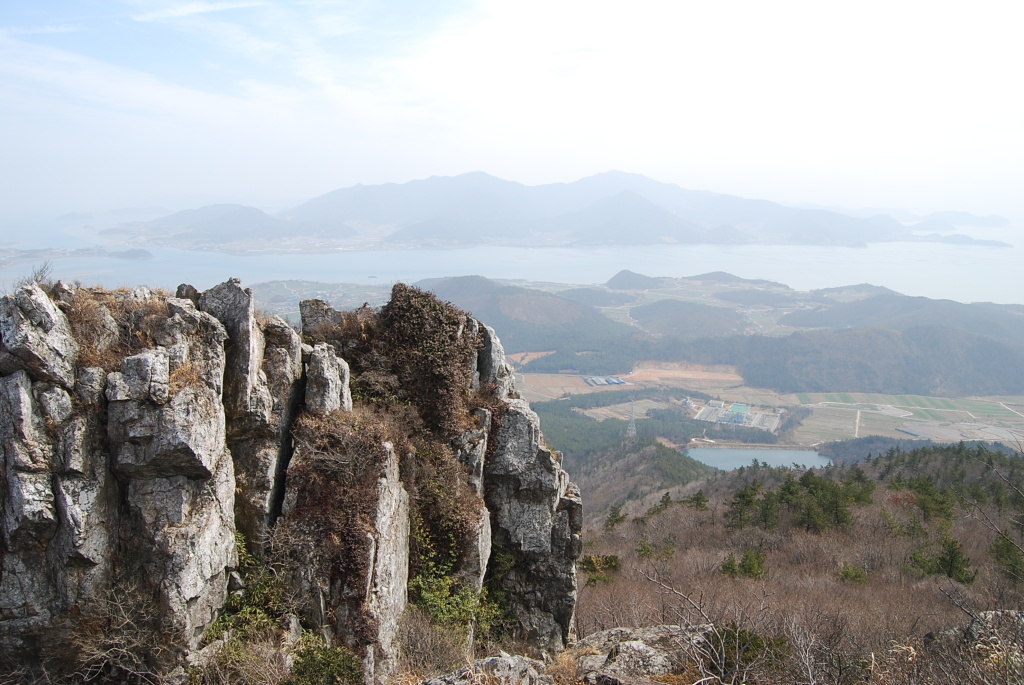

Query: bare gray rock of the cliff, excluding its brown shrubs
[[0, 280, 581, 683]]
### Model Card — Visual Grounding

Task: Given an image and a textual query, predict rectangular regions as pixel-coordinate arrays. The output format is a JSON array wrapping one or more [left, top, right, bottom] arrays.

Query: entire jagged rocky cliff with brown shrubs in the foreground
[[0, 280, 581, 681]]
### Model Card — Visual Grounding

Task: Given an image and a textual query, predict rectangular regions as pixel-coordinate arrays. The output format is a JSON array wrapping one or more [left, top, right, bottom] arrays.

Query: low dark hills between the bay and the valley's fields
[[405, 271, 1024, 396]]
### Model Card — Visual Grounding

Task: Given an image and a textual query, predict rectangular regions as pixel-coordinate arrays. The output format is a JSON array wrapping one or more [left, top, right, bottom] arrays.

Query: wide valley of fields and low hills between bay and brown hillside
[[243, 270, 1024, 462]]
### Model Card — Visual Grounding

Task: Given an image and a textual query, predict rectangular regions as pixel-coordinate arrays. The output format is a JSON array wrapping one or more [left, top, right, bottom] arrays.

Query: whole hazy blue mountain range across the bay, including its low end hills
[[96, 171, 1006, 251]]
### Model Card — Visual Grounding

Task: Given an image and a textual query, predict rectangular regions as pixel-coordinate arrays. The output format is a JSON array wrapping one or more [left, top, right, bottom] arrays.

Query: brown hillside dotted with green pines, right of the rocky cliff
[[577, 445, 1024, 685]]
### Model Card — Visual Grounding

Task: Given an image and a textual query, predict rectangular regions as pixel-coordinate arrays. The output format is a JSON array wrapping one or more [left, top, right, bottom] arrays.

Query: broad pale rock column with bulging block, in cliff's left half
[[106, 300, 238, 648]]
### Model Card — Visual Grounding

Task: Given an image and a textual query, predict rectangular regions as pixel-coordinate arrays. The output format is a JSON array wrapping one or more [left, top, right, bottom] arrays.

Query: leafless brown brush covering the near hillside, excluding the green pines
[[577, 450, 1024, 684]]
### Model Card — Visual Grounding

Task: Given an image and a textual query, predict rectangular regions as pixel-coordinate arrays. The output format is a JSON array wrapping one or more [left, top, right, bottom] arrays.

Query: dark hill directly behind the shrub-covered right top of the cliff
[[416, 275, 638, 353]]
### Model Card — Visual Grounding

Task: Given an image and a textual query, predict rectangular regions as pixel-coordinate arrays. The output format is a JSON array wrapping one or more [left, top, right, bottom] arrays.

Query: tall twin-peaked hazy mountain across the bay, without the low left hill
[[281, 171, 909, 245]]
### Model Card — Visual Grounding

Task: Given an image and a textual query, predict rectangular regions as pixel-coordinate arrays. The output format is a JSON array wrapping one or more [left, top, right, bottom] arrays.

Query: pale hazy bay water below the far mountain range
[[0, 243, 1024, 304]]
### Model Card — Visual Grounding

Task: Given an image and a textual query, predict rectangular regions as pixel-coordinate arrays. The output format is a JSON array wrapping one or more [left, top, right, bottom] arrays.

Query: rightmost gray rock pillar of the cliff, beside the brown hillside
[[484, 399, 583, 650]]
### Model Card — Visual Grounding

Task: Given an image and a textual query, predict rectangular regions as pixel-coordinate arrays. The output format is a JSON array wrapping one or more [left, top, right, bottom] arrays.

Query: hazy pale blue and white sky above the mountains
[[0, 0, 1024, 217]]
